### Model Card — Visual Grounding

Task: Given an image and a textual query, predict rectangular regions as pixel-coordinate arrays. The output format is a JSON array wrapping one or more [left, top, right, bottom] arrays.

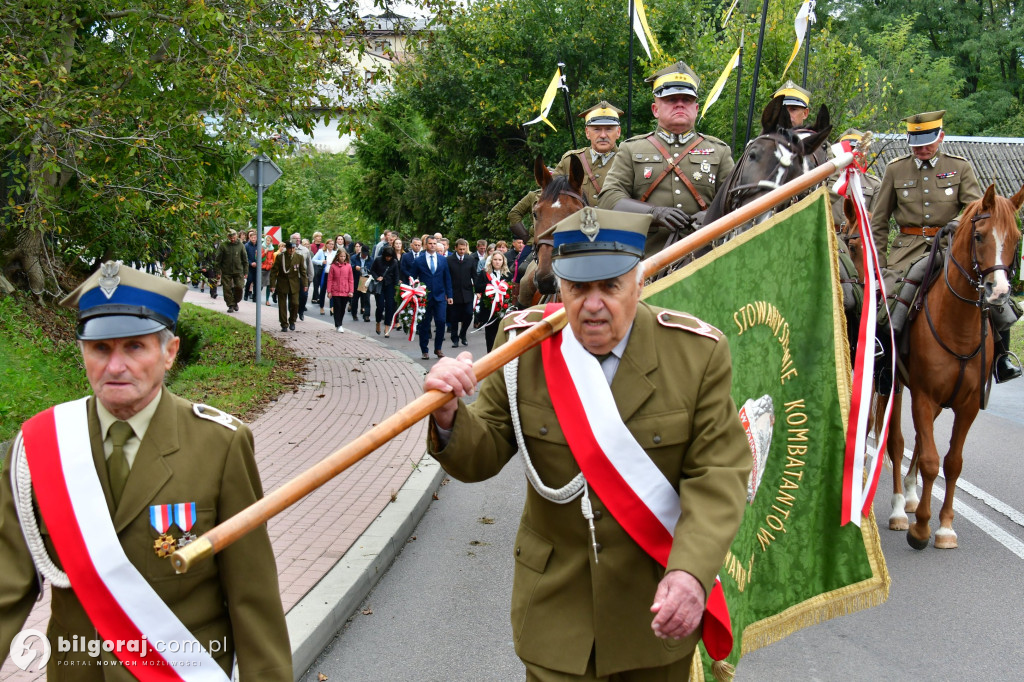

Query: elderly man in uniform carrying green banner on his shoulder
[[424, 207, 751, 681]]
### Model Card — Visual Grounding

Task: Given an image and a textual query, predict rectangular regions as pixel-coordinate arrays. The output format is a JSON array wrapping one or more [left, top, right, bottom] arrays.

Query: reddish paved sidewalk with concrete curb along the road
[[0, 289, 443, 682]]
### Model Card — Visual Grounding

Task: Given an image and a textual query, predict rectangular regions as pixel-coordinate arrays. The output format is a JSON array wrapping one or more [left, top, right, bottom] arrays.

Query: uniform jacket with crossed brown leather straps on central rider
[[597, 128, 735, 255]]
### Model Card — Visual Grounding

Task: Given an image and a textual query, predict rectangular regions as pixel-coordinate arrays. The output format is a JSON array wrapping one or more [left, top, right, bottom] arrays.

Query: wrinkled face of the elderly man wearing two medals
[[82, 334, 181, 419]]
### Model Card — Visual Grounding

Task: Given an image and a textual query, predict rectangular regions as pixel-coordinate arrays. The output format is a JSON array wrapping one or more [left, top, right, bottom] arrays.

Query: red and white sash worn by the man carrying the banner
[[541, 305, 733, 660]]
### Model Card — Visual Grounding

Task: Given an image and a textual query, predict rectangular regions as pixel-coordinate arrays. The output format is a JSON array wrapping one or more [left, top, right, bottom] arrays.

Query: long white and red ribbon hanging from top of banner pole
[[833, 141, 896, 526]]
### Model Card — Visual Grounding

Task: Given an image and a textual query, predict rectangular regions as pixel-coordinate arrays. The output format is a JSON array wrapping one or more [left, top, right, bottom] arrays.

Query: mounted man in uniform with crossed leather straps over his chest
[[598, 61, 735, 255]]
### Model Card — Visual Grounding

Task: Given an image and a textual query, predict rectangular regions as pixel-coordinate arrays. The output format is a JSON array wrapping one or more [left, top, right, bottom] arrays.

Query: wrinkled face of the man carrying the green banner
[[561, 268, 642, 355]]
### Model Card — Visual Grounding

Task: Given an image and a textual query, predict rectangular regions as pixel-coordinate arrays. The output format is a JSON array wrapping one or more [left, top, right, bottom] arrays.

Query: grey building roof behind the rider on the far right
[[871, 134, 1024, 197]]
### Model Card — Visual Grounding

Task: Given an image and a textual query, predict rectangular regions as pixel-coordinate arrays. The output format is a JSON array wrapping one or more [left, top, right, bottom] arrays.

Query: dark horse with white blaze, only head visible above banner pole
[[703, 95, 833, 229]]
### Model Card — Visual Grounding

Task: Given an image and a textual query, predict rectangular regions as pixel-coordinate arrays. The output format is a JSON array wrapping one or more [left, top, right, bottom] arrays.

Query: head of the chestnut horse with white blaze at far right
[[952, 184, 1024, 305]]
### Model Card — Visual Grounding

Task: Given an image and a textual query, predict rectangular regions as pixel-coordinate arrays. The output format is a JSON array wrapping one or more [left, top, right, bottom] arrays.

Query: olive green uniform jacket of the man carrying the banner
[[428, 303, 752, 677]]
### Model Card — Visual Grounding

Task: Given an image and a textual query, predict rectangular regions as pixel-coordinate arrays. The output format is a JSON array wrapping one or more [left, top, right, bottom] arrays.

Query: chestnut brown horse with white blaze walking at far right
[[887, 185, 1024, 550]]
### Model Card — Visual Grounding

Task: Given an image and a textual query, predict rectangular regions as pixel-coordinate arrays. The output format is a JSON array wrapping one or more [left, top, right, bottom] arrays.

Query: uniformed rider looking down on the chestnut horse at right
[[871, 111, 1021, 382]]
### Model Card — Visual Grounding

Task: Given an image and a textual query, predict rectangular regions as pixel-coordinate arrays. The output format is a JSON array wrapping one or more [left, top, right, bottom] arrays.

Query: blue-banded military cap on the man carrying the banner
[[551, 206, 651, 282]]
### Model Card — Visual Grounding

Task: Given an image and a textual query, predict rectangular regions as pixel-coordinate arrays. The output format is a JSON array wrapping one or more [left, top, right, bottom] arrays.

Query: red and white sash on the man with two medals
[[22, 398, 228, 682]]
